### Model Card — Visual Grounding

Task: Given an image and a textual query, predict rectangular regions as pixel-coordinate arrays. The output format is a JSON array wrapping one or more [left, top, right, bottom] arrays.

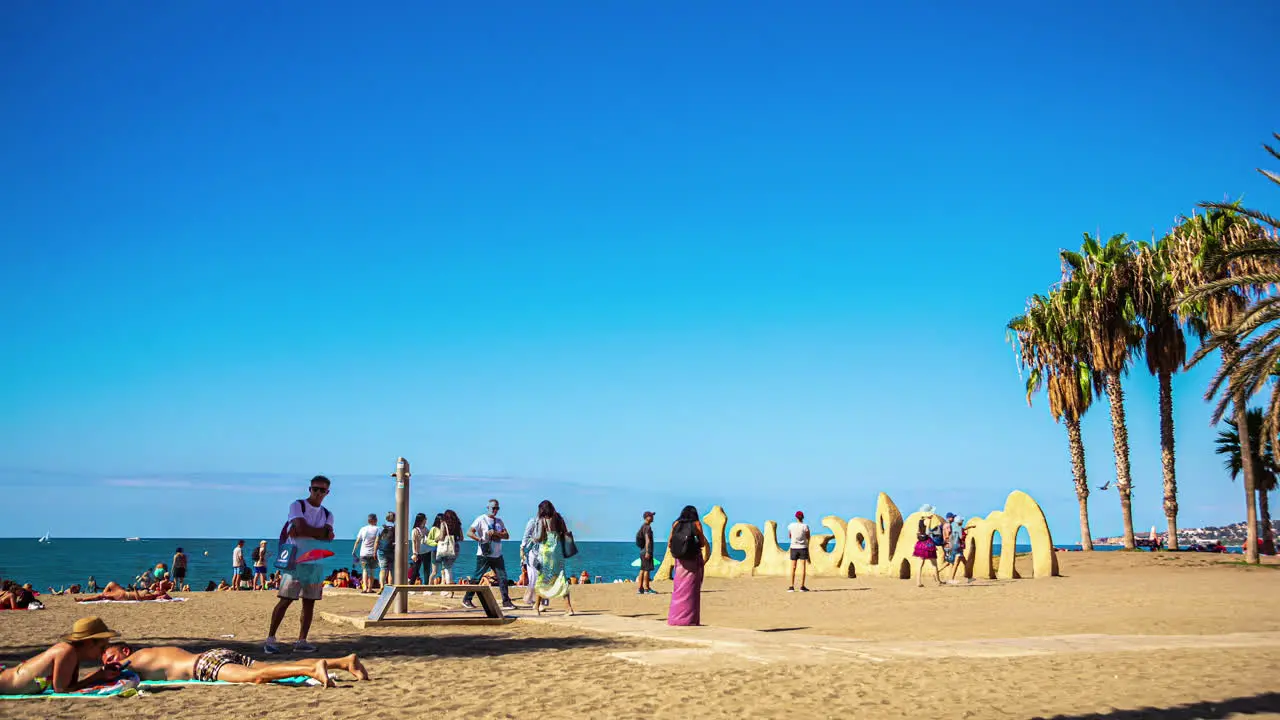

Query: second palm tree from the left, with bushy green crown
[[1061, 233, 1143, 550]]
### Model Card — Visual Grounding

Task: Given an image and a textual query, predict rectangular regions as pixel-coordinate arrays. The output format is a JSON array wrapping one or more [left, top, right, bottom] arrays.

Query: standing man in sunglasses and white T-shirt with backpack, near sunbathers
[[262, 475, 333, 655]]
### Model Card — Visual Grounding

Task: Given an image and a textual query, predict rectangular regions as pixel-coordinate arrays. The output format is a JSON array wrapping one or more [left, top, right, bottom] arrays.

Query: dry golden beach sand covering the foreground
[[0, 545, 1280, 720]]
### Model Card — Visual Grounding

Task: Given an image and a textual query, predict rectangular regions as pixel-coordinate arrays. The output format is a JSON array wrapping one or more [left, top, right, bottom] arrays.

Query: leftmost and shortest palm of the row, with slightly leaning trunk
[[1006, 291, 1094, 552]]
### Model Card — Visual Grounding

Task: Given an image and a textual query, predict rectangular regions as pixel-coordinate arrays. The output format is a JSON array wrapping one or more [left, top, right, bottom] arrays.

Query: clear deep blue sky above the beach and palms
[[0, 0, 1280, 542]]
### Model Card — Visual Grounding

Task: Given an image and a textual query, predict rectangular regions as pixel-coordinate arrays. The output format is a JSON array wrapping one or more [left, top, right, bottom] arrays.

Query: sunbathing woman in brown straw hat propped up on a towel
[[0, 618, 120, 694]]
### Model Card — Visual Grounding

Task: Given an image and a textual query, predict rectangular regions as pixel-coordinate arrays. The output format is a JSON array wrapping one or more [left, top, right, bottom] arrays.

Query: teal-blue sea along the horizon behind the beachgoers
[[0, 537, 1136, 592]]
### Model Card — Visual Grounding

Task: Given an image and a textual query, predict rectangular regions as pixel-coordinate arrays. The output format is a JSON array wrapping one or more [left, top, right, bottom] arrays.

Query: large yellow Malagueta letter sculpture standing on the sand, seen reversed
[[657, 491, 1059, 580]]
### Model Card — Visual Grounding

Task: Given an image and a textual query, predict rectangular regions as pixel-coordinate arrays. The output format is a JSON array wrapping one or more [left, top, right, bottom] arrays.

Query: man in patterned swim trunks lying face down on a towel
[[102, 643, 369, 688]]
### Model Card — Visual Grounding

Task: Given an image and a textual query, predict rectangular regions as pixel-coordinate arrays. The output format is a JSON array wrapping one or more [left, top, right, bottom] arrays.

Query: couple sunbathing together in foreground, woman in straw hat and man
[[0, 618, 369, 694]]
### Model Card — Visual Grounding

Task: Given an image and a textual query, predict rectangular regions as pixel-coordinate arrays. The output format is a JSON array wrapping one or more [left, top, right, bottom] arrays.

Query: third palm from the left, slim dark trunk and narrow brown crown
[[1137, 237, 1187, 550]]
